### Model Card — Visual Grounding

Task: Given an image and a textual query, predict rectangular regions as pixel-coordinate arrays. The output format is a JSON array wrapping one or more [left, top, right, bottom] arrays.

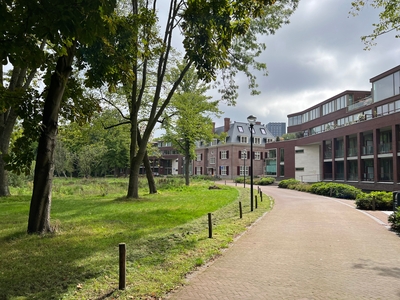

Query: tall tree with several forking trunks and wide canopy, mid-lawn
[[84, 0, 298, 198]]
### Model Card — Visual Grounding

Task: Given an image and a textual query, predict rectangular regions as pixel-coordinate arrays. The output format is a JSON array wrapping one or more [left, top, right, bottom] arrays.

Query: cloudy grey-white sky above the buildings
[[211, 0, 400, 127]]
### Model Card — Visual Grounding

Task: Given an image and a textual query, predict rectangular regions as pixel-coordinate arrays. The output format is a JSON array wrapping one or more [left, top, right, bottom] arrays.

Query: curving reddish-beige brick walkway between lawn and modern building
[[169, 186, 400, 300]]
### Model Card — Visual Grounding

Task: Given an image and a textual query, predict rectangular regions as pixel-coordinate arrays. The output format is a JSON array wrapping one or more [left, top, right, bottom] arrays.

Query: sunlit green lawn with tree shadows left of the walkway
[[0, 179, 271, 300]]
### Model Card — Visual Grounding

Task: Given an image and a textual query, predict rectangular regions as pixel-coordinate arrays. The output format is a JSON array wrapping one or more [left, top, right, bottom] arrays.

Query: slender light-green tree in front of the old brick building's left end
[[163, 68, 220, 185]]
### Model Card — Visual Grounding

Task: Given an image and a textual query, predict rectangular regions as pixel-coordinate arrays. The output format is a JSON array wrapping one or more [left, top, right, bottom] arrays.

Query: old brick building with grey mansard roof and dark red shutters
[[193, 118, 275, 179]]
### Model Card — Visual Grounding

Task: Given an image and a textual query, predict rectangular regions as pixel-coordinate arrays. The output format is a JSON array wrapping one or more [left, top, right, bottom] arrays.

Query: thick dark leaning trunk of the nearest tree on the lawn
[[28, 45, 75, 234]]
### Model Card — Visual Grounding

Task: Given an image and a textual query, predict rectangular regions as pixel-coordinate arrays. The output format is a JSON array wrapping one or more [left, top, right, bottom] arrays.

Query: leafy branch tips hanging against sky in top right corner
[[351, 0, 400, 50]]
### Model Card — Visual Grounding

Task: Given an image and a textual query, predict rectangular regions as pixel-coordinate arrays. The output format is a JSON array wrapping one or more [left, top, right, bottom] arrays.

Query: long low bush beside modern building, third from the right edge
[[310, 182, 361, 199]]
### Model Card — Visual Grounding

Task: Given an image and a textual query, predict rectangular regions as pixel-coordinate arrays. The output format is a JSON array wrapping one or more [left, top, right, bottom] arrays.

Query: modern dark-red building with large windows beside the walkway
[[265, 66, 400, 191]]
